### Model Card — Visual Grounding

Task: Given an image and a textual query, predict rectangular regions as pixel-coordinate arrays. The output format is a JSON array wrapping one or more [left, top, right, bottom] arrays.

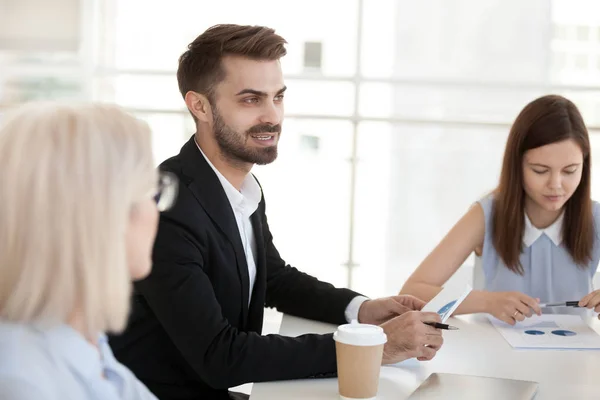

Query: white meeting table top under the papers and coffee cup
[[250, 315, 600, 400]]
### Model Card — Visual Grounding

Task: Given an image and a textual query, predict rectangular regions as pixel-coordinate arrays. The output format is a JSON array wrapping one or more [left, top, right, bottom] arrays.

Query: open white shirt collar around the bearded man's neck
[[194, 138, 262, 217]]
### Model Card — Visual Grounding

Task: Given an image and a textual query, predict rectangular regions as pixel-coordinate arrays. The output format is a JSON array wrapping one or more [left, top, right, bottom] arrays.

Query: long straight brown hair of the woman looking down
[[492, 95, 594, 274]]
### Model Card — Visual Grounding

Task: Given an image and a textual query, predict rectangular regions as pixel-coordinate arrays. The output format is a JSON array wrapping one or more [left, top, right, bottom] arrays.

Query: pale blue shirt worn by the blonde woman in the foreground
[[0, 321, 157, 400]]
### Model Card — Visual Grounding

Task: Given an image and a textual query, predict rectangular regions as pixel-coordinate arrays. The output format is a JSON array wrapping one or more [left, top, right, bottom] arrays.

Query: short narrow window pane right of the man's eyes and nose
[[285, 79, 354, 117]]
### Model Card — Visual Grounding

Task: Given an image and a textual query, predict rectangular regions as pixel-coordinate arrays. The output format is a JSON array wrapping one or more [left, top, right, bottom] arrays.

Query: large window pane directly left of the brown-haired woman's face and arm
[[354, 122, 508, 296]]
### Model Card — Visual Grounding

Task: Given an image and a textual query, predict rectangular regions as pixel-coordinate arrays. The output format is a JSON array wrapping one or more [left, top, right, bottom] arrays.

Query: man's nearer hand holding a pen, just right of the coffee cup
[[381, 311, 444, 365]]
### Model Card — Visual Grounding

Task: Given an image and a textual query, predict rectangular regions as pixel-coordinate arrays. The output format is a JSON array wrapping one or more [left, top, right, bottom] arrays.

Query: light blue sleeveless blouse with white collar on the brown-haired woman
[[479, 196, 600, 303]]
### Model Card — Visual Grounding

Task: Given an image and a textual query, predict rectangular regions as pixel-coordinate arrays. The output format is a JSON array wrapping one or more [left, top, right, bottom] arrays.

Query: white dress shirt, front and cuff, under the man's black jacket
[[196, 142, 368, 322]]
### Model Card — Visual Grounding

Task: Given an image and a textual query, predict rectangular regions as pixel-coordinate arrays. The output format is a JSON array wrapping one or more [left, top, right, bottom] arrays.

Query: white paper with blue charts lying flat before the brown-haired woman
[[489, 314, 600, 350]]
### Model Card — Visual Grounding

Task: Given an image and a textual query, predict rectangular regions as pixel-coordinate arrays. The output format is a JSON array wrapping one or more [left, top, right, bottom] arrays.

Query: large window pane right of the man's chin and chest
[[253, 119, 352, 287]]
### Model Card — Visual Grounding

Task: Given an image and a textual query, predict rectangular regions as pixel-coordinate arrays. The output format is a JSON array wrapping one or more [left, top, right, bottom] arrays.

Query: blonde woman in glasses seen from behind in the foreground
[[0, 104, 175, 400]]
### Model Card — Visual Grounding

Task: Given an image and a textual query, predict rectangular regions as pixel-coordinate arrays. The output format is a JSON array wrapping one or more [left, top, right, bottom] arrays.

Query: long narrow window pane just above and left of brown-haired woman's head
[[359, 83, 542, 124]]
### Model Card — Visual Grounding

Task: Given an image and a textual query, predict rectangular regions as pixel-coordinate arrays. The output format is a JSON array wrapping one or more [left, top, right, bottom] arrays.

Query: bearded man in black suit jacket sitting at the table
[[111, 25, 442, 400]]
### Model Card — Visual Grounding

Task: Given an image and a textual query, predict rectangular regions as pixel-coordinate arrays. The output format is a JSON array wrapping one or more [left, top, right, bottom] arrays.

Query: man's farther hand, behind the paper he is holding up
[[358, 295, 425, 325]]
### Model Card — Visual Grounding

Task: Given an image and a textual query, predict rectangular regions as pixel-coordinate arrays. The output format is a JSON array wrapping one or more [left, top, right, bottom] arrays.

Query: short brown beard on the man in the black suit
[[213, 108, 281, 165]]
